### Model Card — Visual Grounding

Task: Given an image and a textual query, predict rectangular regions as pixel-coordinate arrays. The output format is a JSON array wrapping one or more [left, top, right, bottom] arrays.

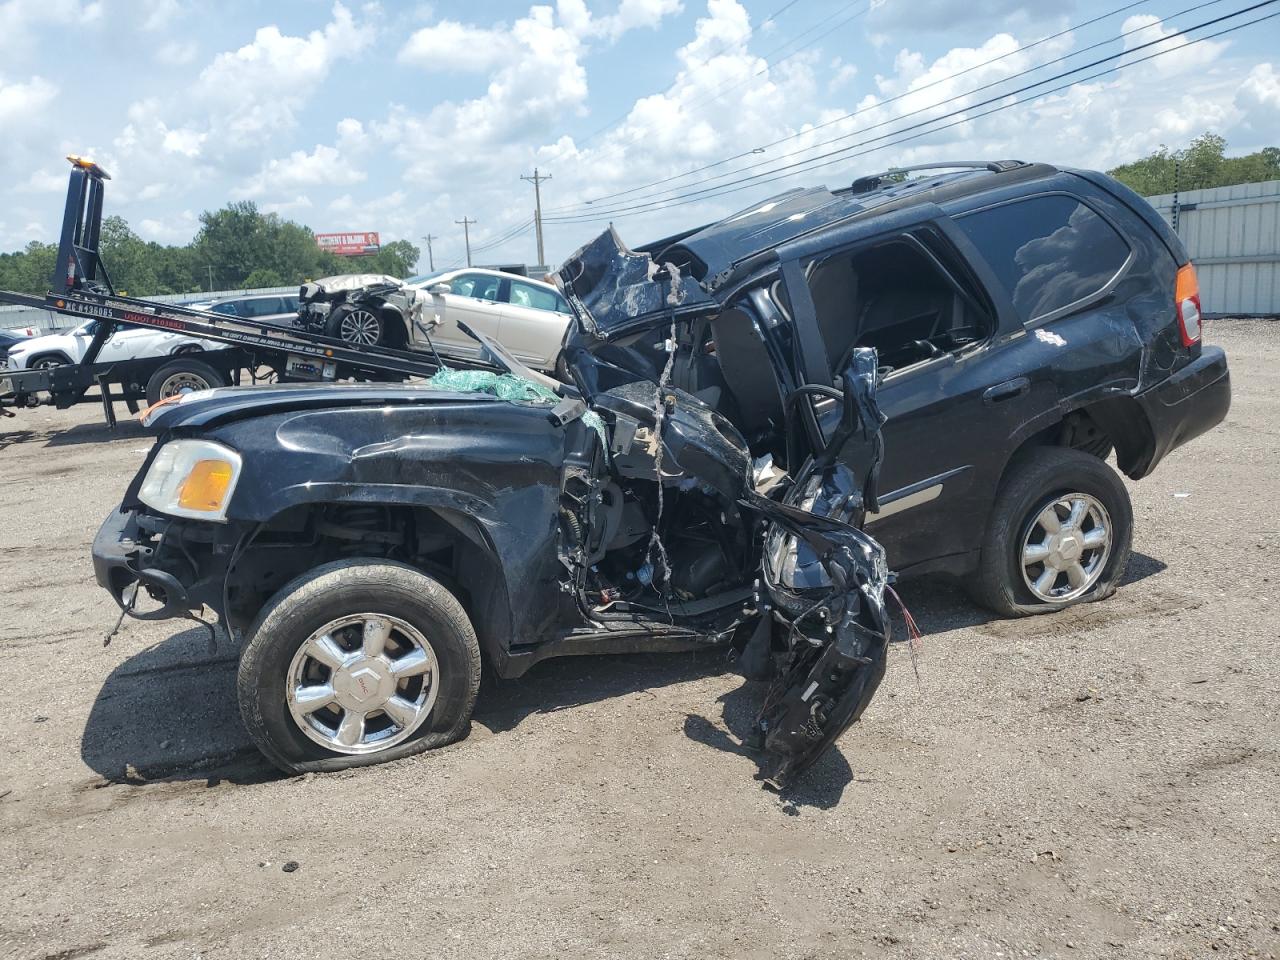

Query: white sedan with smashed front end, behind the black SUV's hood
[[300, 268, 570, 370]]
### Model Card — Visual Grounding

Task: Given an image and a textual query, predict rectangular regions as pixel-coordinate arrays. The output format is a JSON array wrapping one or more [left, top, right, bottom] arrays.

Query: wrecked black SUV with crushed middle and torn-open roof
[[93, 161, 1230, 785]]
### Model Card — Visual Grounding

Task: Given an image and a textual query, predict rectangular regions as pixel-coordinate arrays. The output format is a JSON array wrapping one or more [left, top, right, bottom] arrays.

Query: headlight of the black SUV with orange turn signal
[[138, 440, 241, 524]]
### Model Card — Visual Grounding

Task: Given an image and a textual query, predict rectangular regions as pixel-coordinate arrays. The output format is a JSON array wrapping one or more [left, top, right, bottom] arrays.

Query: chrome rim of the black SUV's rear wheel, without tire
[[1021, 493, 1111, 603]]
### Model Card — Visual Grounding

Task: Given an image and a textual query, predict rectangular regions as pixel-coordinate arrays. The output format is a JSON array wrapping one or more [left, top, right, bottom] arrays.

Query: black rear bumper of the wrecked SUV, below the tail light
[[1137, 347, 1231, 474]]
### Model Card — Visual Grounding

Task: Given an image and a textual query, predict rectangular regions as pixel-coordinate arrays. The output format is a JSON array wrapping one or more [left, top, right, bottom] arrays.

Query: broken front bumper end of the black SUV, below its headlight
[[93, 508, 223, 620]]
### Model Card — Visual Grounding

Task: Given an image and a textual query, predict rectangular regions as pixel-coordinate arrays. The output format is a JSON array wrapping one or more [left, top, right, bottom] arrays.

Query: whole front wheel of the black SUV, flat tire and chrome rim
[[237, 559, 480, 773]]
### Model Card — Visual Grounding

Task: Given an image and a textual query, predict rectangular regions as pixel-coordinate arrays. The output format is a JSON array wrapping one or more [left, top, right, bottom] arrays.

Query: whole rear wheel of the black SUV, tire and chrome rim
[[966, 447, 1133, 617]]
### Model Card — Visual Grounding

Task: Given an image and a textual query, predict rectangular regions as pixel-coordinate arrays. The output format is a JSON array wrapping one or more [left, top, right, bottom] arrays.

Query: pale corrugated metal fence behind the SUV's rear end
[[1147, 180, 1280, 316]]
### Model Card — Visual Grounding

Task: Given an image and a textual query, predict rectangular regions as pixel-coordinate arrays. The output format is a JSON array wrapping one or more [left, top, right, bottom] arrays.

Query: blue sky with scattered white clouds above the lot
[[0, 0, 1280, 269]]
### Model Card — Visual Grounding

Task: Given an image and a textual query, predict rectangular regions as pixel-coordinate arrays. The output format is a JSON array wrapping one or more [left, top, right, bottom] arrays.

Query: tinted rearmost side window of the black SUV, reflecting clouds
[[956, 193, 1129, 323]]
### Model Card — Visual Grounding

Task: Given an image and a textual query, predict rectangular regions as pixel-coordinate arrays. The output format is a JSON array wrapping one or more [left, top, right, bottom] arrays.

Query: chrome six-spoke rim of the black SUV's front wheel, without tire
[[285, 613, 439, 754]]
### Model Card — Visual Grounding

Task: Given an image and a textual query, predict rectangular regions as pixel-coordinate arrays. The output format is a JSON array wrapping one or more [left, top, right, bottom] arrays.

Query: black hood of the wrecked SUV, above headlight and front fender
[[143, 383, 498, 433]]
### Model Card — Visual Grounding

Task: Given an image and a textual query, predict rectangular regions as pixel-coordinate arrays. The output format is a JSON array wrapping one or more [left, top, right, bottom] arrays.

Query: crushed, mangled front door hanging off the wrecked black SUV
[[741, 349, 891, 788]]
